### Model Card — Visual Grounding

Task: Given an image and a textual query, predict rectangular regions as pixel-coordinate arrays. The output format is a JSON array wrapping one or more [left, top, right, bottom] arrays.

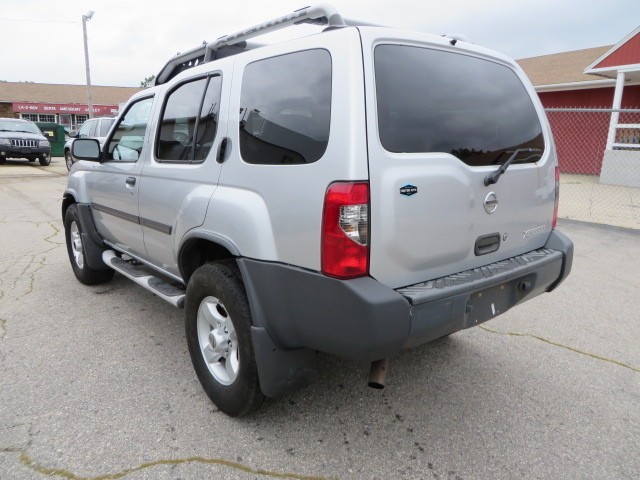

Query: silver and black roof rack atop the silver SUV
[[154, 4, 352, 85]]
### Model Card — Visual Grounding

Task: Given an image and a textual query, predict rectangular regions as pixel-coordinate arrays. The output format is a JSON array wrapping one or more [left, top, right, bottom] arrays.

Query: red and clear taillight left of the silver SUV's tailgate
[[322, 182, 369, 279]]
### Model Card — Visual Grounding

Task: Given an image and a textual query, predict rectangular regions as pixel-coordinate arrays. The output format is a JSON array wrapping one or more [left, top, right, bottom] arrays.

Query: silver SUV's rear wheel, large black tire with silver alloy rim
[[185, 262, 264, 417]]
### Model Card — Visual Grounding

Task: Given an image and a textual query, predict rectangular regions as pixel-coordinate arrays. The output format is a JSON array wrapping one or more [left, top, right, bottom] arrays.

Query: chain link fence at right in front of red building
[[546, 108, 640, 229]]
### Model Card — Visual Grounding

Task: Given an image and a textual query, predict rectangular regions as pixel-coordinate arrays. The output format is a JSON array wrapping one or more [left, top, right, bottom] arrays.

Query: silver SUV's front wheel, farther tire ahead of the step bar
[[64, 203, 114, 285]]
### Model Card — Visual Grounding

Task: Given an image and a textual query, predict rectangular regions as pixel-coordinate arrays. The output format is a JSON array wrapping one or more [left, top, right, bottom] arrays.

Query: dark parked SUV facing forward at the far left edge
[[0, 118, 51, 166]]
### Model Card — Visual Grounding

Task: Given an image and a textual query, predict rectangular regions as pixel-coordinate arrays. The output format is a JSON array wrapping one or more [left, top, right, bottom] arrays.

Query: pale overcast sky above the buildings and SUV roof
[[0, 0, 640, 86]]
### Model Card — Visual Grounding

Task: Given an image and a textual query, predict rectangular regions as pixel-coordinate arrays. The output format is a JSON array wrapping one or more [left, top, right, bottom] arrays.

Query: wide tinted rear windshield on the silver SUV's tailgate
[[375, 45, 544, 166]]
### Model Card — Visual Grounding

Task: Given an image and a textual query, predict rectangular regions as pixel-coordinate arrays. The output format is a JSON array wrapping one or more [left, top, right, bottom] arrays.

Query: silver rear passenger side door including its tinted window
[[140, 67, 231, 277]]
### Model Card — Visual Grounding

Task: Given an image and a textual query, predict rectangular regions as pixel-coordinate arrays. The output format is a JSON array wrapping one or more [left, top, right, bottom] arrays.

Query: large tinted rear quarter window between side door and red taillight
[[240, 49, 331, 165]]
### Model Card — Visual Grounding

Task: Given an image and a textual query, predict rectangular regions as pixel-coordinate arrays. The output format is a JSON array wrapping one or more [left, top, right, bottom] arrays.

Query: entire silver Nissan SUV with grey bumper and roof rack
[[62, 6, 573, 416]]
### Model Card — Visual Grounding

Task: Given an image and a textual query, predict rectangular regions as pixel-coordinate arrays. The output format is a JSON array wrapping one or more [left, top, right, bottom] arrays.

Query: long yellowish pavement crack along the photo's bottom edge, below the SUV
[[20, 449, 328, 480]]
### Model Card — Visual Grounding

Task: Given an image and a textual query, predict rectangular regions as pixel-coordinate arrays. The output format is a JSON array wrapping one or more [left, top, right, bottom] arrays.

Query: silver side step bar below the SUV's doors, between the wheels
[[102, 250, 185, 308]]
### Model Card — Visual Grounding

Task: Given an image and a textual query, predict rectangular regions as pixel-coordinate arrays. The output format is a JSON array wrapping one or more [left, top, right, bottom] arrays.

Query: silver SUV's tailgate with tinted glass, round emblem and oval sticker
[[363, 32, 556, 288]]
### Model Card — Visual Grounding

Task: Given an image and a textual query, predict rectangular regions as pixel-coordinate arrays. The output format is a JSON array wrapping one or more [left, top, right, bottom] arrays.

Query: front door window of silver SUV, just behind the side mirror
[[104, 97, 153, 162]]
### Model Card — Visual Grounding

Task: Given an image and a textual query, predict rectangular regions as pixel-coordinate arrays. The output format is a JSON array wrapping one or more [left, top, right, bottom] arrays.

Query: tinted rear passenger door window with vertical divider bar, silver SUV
[[156, 75, 222, 162]]
